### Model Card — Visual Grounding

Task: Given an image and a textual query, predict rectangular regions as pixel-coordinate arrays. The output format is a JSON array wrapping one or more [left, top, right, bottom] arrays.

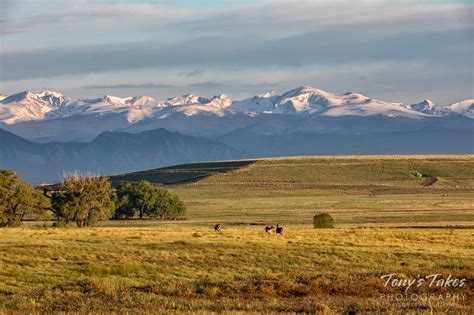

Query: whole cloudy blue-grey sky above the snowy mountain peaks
[[0, 0, 474, 105]]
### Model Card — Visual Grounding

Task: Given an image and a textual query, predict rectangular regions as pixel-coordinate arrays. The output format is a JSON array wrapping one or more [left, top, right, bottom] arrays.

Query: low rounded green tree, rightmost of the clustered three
[[115, 181, 186, 219]]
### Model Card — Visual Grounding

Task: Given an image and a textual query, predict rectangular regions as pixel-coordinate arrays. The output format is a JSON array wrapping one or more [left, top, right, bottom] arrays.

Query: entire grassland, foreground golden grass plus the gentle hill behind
[[0, 155, 474, 314]]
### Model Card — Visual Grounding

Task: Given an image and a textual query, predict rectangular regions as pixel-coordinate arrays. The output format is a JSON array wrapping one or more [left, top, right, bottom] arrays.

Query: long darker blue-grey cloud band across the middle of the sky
[[0, 27, 474, 81]]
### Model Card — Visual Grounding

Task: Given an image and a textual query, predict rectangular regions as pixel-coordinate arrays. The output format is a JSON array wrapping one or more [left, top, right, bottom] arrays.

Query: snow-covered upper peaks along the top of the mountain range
[[0, 86, 474, 124]]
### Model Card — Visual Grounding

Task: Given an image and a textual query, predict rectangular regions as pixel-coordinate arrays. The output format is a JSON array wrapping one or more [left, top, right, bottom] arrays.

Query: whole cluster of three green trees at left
[[0, 170, 186, 227]]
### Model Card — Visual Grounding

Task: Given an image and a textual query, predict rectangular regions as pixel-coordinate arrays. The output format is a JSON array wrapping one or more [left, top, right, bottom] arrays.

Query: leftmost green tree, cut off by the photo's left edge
[[0, 170, 50, 226]]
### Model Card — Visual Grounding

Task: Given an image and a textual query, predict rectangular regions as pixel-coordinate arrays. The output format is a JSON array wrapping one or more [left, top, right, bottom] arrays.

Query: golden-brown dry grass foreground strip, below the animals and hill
[[0, 224, 474, 312]]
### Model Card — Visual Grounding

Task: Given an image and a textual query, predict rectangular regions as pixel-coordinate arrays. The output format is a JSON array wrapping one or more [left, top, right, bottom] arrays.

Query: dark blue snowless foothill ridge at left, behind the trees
[[0, 129, 241, 183]]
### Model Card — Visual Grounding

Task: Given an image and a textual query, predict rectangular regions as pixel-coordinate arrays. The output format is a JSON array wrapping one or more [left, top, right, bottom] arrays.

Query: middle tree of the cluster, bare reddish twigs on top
[[51, 175, 115, 227]]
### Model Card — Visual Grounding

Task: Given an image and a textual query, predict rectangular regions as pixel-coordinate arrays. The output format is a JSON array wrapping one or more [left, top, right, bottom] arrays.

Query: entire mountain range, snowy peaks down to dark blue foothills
[[0, 86, 474, 182]]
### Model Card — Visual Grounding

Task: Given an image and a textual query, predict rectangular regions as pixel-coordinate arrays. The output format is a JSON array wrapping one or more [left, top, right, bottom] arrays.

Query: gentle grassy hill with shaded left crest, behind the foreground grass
[[112, 155, 474, 226]]
